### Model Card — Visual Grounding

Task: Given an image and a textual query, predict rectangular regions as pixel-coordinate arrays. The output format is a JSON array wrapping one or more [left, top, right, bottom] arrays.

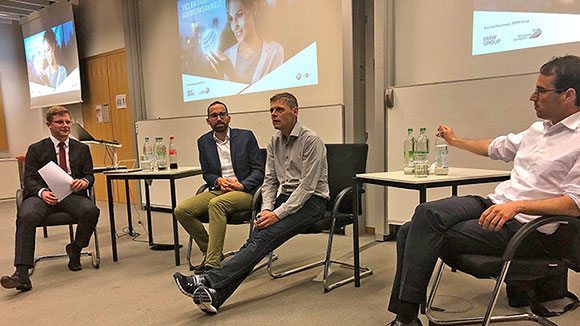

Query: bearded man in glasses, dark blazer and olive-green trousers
[[175, 101, 264, 273]]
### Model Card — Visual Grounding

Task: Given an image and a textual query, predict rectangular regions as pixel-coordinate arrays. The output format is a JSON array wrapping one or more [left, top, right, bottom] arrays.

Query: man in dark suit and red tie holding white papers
[[0, 106, 99, 291]]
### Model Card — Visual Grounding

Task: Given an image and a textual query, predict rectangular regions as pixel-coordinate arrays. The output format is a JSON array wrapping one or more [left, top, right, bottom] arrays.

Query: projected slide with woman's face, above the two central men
[[177, 0, 318, 102]]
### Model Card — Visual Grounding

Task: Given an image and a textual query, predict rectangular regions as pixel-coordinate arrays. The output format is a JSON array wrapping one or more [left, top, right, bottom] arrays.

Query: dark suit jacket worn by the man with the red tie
[[24, 138, 95, 199]]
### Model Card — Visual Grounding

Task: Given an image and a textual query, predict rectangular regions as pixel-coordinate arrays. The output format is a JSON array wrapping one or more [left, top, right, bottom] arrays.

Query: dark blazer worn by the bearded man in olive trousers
[[197, 128, 264, 193]]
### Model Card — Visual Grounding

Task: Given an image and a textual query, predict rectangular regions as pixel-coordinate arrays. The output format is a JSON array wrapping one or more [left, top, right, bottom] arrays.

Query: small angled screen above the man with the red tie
[[22, 5, 81, 108]]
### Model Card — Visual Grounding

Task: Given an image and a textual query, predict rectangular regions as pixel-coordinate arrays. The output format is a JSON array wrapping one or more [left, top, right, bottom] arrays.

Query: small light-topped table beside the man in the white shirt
[[353, 167, 511, 286]]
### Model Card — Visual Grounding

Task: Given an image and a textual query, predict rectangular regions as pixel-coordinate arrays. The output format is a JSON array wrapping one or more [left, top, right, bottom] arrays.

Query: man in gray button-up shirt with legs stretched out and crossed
[[173, 93, 330, 314]]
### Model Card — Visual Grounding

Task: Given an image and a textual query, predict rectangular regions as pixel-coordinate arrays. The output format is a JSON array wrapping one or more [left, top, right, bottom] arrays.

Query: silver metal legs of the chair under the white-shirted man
[[425, 261, 558, 326]]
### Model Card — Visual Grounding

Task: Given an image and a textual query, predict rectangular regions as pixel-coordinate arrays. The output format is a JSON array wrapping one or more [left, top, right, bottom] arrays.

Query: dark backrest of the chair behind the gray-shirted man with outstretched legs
[[326, 144, 369, 213]]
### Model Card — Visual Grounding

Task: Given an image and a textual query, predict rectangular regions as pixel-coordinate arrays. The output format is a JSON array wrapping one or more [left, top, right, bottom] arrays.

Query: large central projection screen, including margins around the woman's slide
[[139, 0, 344, 119]]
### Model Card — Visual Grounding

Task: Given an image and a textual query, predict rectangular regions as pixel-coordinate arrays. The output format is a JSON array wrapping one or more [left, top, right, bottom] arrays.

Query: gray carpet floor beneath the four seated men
[[0, 201, 580, 326]]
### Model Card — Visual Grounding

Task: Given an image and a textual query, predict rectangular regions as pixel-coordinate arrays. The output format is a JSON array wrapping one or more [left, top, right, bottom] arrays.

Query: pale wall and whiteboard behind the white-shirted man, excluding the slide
[[376, 0, 580, 232]]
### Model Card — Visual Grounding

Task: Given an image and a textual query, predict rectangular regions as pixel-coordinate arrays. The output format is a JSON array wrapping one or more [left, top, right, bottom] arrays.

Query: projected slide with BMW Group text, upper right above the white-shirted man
[[472, 0, 580, 55]]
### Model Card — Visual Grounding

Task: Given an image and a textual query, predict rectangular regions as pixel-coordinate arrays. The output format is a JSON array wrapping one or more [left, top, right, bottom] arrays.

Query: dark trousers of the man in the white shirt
[[388, 196, 548, 313]]
